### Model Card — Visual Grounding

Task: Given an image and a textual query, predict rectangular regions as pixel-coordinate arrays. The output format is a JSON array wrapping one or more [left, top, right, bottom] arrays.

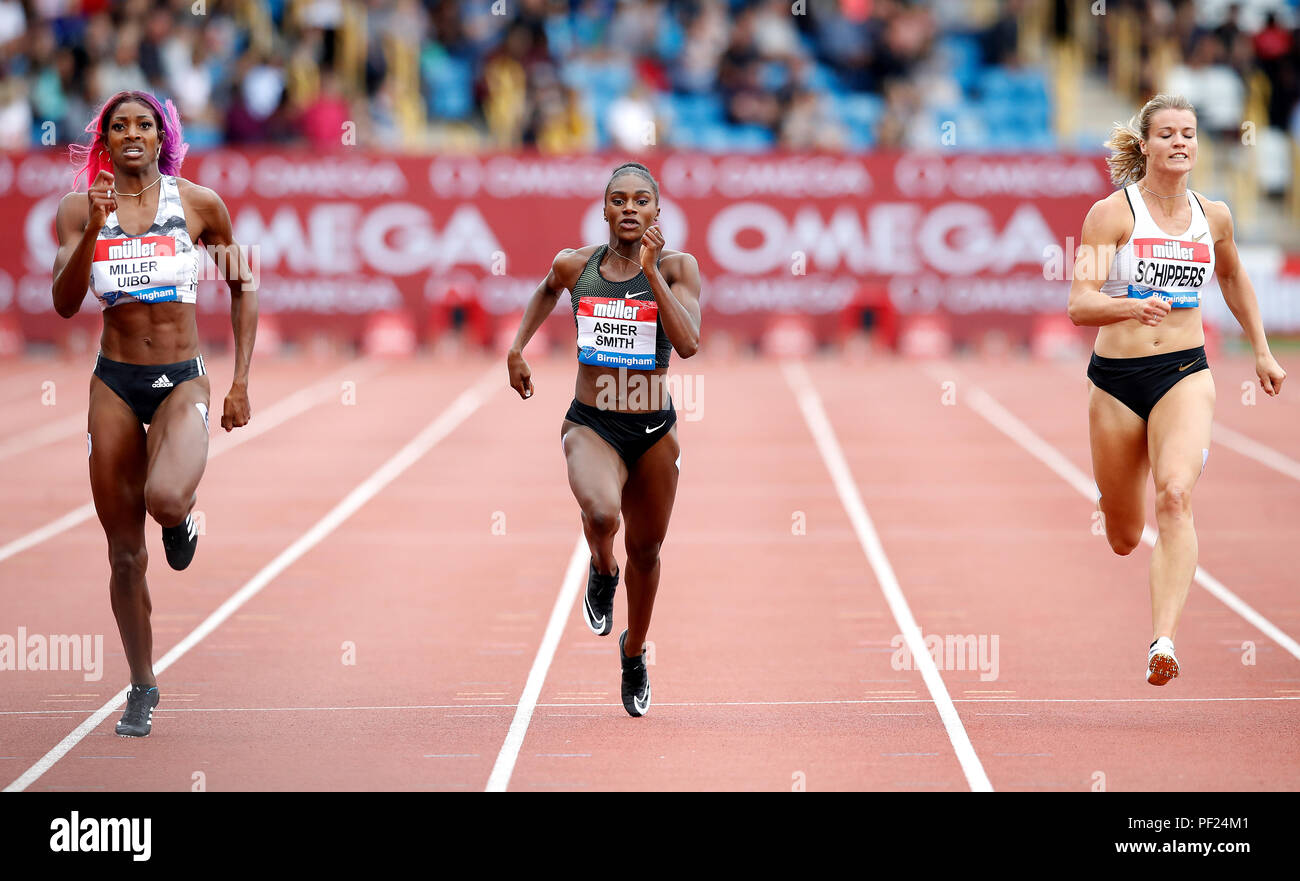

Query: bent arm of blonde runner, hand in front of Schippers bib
[[1067, 198, 1170, 327]]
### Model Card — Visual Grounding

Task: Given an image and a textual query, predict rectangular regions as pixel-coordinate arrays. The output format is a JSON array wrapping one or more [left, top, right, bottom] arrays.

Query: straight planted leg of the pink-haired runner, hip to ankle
[[86, 376, 156, 686]]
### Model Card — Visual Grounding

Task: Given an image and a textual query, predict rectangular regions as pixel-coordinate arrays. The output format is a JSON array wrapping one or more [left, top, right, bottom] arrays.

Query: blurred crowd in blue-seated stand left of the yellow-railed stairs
[[0, 0, 1050, 153]]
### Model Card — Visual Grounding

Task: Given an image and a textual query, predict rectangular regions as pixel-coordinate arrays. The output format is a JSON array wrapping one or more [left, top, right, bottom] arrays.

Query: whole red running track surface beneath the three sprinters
[[0, 357, 1300, 790]]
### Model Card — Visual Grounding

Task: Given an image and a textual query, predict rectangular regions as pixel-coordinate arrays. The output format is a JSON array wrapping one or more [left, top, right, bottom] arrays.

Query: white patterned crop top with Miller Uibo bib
[[90, 174, 200, 309]]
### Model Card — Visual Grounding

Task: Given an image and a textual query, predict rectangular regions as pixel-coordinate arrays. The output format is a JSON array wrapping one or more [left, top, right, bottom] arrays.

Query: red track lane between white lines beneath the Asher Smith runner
[[496, 357, 966, 791]]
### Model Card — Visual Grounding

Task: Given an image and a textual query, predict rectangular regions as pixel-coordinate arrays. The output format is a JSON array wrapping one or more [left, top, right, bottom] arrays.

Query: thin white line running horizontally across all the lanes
[[0, 695, 1300, 717]]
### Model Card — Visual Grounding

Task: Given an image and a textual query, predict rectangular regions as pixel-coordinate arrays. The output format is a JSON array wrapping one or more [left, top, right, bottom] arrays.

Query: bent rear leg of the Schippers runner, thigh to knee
[[1088, 382, 1148, 555]]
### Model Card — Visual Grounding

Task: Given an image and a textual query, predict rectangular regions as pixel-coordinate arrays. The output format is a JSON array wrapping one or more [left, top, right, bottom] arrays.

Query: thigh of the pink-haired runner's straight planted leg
[[86, 376, 147, 548]]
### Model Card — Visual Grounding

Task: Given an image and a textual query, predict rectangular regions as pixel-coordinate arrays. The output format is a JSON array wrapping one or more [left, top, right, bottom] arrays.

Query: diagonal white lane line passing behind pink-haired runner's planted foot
[[4, 366, 501, 793]]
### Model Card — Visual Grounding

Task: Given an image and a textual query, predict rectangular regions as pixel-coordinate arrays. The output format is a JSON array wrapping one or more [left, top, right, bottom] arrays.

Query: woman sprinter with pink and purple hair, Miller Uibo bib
[[53, 92, 257, 737]]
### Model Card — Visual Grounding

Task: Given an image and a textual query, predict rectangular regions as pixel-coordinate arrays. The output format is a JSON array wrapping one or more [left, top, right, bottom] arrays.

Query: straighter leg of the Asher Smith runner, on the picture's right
[[623, 426, 681, 658]]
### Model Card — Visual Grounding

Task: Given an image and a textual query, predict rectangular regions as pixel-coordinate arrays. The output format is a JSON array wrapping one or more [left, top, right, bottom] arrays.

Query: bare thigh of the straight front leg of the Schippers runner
[[1147, 370, 1214, 490]]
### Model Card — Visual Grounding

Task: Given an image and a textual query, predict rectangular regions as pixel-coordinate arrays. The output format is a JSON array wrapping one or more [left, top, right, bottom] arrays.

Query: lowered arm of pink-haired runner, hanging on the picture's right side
[[186, 183, 257, 431]]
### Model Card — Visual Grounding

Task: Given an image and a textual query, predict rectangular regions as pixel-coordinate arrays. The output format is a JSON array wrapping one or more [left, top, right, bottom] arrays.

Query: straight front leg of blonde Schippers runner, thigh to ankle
[[1148, 370, 1214, 639]]
